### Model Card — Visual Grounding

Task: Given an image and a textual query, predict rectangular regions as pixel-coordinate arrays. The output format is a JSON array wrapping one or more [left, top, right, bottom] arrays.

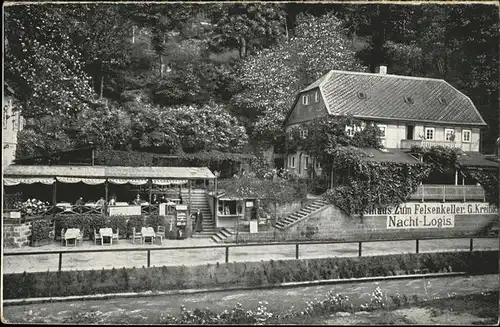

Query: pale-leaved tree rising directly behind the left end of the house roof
[[231, 13, 364, 144]]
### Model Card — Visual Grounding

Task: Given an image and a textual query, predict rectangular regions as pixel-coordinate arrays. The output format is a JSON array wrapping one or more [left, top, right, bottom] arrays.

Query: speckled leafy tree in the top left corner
[[5, 5, 95, 117]]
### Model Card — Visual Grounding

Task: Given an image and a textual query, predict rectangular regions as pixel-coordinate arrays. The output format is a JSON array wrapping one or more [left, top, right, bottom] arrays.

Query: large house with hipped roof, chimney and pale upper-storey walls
[[285, 66, 487, 177]]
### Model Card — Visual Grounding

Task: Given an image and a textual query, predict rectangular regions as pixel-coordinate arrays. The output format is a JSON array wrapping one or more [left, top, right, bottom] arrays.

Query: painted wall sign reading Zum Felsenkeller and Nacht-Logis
[[366, 202, 498, 229]]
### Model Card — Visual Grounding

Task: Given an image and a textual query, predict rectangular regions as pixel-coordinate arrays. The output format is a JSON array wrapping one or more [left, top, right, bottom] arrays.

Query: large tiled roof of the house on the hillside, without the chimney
[[291, 70, 486, 126]]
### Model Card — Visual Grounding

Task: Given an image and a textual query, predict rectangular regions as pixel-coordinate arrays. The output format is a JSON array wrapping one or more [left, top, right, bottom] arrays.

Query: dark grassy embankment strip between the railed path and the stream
[[3, 251, 498, 299]]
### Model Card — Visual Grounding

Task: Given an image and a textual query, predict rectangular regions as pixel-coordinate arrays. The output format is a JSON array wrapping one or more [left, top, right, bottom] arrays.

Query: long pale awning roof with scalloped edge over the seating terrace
[[3, 165, 215, 186]]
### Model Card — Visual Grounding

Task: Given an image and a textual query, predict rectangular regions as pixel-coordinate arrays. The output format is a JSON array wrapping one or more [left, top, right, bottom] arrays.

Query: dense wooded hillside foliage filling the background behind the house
[[4, 3, 499, 167]]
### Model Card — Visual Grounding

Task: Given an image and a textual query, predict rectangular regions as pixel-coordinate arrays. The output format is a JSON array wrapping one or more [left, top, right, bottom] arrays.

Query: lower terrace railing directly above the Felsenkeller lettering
[[410, 184, 485, 202]]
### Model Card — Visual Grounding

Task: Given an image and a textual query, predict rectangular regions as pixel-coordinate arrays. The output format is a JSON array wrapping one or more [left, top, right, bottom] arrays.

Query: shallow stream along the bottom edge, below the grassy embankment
[[3, 274, 499, 325]]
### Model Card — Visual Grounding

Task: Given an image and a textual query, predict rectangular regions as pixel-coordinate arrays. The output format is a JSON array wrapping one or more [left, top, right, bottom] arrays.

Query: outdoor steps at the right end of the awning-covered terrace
[[181, 188, 215, 238]]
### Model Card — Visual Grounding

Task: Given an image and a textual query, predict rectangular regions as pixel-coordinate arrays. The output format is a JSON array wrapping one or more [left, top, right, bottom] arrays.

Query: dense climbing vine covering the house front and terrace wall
[[286, 116, 498, 217]]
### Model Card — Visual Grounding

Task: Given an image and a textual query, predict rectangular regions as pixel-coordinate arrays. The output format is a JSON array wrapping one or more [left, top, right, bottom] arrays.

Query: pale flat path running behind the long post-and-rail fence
[[2, 238, 499, 274]]
